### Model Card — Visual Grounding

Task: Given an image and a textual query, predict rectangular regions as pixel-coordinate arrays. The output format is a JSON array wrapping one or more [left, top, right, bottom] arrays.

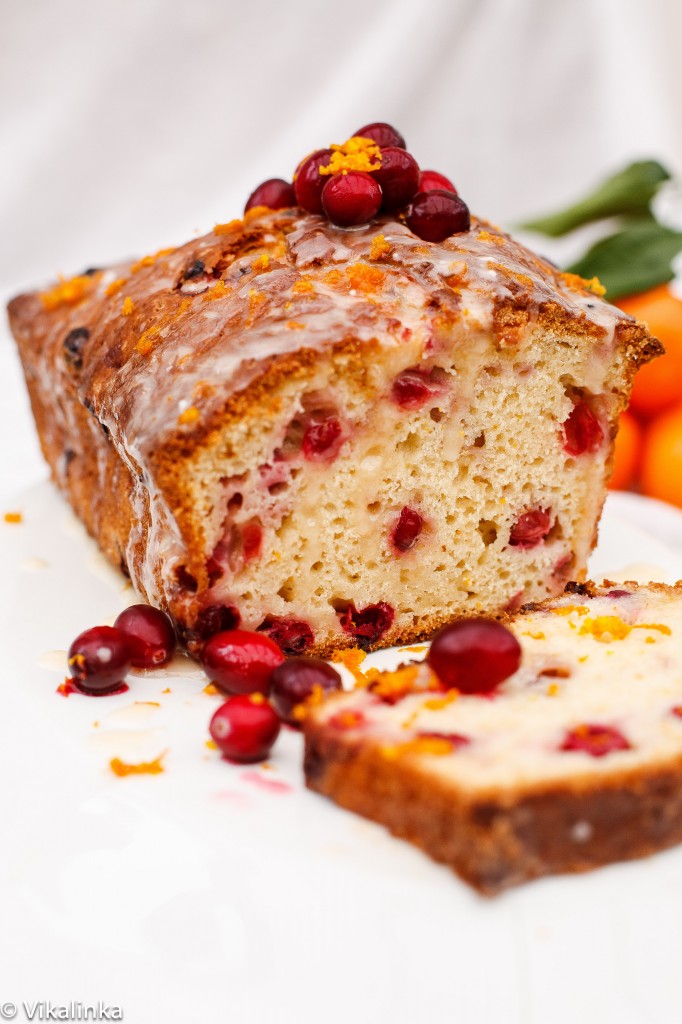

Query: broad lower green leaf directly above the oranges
[[568, 218, 682, 301]]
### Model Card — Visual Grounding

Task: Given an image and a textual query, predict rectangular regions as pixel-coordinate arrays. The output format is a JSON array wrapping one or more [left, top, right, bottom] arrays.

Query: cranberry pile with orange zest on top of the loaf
[[240, 122, 470, 242]]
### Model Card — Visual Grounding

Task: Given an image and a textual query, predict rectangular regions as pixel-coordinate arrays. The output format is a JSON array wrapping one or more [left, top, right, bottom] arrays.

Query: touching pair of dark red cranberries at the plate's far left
[[68, 604, 175, 695]]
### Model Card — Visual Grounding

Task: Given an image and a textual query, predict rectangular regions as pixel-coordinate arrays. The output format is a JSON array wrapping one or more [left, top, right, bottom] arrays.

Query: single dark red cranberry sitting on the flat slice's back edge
[[427, 618, 521, 693]]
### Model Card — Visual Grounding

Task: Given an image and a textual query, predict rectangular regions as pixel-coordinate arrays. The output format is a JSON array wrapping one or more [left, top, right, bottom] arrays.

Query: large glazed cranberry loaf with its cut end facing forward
[[9, 207, 659, 654]]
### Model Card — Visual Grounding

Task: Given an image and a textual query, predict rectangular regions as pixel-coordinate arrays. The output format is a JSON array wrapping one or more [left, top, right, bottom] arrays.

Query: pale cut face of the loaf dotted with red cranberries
[[163, 315, 624, 653]]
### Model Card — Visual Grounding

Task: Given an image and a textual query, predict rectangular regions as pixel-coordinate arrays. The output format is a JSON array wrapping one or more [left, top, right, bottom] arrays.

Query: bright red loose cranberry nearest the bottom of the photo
[[209, 693, 281, 764]]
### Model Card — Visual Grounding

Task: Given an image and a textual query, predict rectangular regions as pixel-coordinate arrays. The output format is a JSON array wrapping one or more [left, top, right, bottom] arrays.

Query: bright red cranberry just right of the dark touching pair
[[201, 630, 284, 693]]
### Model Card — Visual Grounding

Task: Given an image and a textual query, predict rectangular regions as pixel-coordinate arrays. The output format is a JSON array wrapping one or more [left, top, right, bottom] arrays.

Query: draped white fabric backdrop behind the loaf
[[0, 0, 682, 502]]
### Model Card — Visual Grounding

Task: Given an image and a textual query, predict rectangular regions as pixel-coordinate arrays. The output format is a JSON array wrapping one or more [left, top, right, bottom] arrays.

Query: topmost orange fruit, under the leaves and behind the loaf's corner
[[617, 285, 682, 417]]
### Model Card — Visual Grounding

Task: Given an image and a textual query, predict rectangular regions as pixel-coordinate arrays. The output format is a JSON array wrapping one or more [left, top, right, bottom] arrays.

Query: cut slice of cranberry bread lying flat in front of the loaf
[[305, 584, 682, 895]]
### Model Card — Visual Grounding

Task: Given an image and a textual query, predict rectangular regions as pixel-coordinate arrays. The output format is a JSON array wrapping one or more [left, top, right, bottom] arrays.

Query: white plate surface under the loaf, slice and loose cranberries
[[0, 483, 682, 1024]]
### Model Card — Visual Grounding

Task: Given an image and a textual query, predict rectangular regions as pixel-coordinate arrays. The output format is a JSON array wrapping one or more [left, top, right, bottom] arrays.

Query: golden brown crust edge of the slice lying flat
[[304, 719, 682, 896]]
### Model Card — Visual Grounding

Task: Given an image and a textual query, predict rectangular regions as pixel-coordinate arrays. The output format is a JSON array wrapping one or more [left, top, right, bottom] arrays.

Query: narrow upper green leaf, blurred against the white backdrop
[[521, 160, 670, 238]]
